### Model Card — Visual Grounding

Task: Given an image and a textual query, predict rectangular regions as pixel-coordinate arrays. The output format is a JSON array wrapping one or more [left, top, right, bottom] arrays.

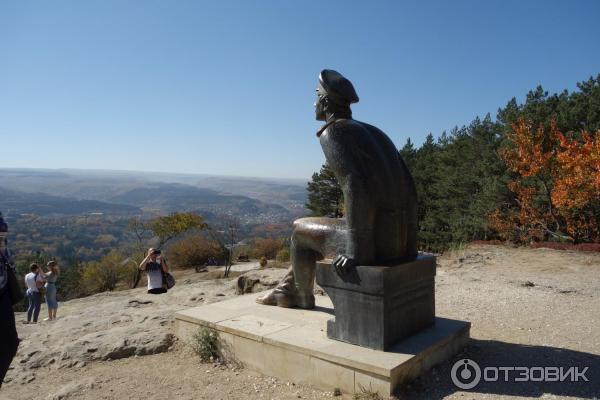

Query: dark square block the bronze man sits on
[[317, 256, 435, 351]]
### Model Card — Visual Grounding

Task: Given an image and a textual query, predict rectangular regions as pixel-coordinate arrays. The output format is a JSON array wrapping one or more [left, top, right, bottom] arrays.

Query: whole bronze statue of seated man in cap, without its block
[[256, 70, 417, 308]]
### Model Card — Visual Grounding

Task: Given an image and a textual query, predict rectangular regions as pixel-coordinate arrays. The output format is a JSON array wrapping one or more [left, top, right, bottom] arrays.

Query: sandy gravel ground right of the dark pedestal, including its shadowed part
[[400, 246, 600, 399]]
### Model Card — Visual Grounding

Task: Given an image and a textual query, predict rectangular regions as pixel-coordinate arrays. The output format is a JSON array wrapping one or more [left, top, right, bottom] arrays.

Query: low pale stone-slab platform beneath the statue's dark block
[[175, 294, 470, 396]]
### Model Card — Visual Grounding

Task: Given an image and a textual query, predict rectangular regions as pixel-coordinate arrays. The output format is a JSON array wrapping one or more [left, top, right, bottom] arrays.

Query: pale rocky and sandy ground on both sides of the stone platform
[[0, 246, 600, 400]]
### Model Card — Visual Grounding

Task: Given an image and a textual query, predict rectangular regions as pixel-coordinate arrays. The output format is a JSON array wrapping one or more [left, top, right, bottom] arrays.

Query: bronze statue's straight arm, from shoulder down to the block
[[321, 128, 375, 264]]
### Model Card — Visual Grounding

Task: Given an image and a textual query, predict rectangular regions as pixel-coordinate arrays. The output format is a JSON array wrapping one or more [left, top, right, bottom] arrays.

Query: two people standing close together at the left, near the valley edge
[[25, 261, 60, 324]]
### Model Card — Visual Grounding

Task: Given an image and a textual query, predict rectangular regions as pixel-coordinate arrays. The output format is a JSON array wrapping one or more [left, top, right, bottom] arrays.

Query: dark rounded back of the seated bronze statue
[[321, 119, 417, 263]]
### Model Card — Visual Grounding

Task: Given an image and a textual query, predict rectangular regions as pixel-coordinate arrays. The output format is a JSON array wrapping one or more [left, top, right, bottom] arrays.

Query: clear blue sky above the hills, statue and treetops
[[0, 0, 600, 178]]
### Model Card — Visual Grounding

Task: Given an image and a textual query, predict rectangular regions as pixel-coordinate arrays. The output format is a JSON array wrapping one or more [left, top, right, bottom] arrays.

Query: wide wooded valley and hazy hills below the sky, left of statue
[[0, 169, 307, 262]]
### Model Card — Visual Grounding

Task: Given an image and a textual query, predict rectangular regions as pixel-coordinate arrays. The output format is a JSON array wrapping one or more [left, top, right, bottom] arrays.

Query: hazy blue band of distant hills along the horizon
[[0, 169, 306, 224]]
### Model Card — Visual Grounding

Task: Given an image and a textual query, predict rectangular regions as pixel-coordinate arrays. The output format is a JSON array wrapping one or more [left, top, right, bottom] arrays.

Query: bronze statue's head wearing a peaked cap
[[315, 69, 358, 121]]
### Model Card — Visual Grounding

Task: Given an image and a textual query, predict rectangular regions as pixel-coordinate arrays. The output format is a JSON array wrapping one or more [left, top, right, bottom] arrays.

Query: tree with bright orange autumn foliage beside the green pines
[[489, 118, 600, 242]]
